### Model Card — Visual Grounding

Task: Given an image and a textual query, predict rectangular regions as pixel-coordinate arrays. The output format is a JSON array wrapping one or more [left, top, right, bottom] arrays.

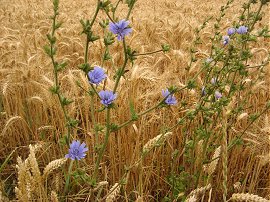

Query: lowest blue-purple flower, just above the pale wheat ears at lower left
[[65, 140, 88, 160]]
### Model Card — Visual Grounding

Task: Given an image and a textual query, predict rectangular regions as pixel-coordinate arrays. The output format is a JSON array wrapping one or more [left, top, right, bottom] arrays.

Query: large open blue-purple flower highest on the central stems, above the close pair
[[109, 20, 132, 41]]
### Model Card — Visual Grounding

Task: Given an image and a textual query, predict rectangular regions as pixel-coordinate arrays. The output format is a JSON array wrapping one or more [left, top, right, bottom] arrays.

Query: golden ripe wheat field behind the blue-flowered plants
[[0, 0, 270, 201]]
